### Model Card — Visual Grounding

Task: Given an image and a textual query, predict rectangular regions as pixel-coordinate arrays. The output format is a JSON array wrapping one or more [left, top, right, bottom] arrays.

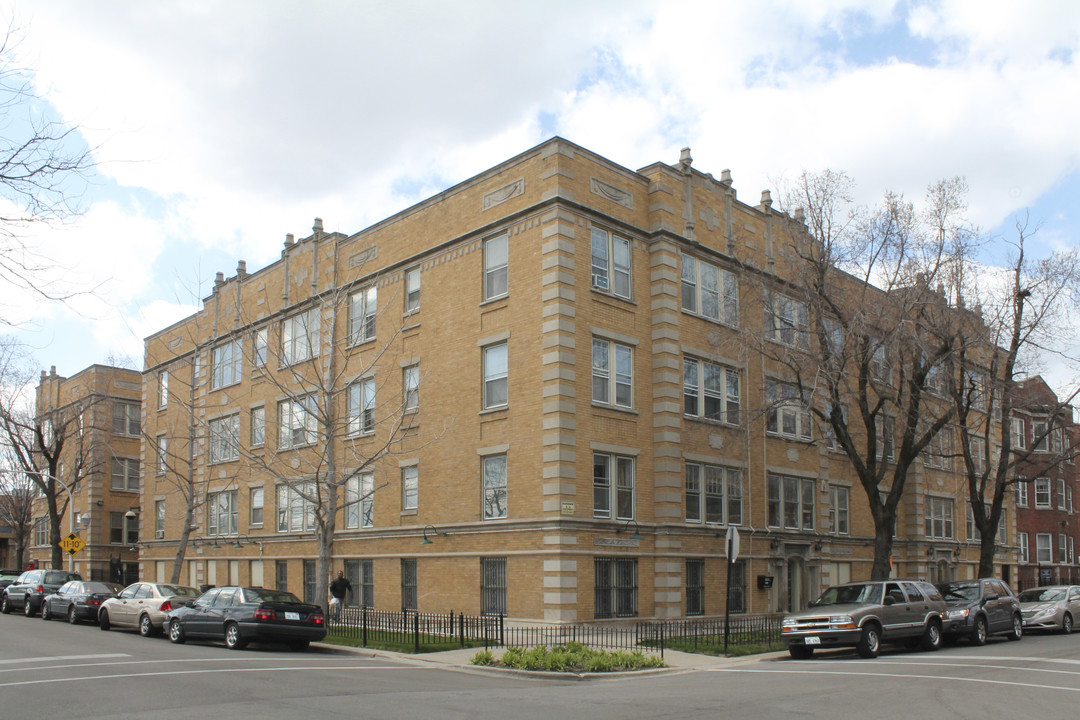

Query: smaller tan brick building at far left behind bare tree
[[30, 365, 143, 582]]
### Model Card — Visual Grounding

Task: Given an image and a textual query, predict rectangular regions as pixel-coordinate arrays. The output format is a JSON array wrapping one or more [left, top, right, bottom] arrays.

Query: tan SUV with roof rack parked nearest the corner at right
[[781, 580, 946, 658]]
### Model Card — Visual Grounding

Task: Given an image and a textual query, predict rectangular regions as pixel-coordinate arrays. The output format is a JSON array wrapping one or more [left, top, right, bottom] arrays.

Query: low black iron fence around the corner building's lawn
[[327, 608, 783, 656]]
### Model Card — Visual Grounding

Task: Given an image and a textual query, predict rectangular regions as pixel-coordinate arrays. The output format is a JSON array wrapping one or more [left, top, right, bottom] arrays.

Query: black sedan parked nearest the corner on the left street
[[167, 586, 326, 650]]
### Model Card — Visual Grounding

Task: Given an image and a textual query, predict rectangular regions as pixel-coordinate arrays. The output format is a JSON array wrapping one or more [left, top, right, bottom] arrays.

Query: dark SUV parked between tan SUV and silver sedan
[[937, 578, 1024, 646]]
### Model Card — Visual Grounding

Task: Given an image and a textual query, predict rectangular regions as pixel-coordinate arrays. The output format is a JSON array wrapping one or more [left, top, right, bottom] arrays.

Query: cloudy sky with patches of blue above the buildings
[[0, 0, 1080, 388]]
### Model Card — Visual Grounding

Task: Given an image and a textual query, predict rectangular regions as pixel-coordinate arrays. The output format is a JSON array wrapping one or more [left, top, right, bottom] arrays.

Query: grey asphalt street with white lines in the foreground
[[6, 615, 1080, 720]]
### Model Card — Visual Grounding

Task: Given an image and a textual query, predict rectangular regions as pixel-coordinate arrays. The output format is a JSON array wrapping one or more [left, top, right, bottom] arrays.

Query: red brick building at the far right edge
[[1012, 376, 1080, 587]]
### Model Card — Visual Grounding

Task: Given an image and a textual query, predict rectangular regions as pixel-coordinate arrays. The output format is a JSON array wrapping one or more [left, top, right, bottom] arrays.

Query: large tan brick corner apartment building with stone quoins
[[132, 138, 1015, 622]]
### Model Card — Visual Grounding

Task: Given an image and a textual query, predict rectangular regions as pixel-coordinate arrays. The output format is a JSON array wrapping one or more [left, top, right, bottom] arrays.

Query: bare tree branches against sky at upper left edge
[[0, 22, 94, 324]]
